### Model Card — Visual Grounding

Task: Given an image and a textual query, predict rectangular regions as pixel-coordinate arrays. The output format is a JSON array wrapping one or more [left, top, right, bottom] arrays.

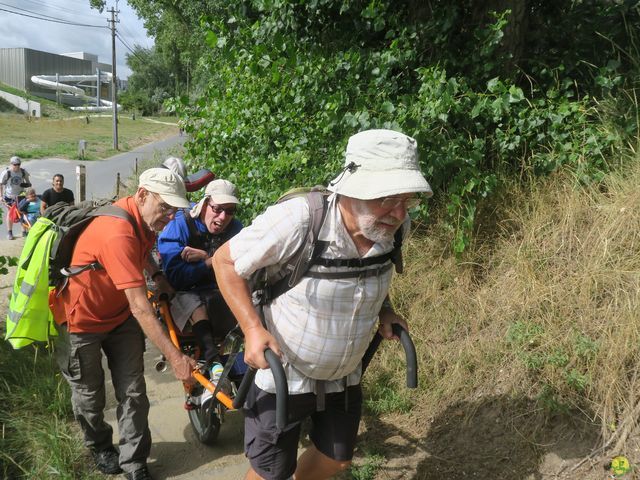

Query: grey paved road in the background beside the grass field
[[0, 135, 186, 238]]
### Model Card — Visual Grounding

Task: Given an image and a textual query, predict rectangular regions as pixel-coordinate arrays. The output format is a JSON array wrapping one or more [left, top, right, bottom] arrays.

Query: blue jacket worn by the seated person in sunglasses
[[158, 210, 242, 291]]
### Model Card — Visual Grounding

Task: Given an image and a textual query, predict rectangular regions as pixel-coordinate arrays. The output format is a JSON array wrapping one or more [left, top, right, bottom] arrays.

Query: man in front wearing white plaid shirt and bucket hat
[[213, 130, 432, 480]]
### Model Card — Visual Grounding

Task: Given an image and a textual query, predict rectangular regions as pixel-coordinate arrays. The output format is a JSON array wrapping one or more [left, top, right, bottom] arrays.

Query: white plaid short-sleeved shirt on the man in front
[[229, 194, 410, 394]]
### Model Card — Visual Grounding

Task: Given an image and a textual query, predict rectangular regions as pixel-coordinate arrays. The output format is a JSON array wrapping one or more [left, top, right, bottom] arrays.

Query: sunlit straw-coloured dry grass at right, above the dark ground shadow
[[371, 161, 640, 450]]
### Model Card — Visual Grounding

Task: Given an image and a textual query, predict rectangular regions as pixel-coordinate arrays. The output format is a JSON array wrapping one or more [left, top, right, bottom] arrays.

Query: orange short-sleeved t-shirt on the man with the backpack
[[55, 197, 156, 333]]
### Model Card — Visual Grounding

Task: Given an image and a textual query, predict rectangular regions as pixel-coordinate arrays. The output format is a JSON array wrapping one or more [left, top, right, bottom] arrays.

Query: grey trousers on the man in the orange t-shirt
[[56, 317, 151, 472]]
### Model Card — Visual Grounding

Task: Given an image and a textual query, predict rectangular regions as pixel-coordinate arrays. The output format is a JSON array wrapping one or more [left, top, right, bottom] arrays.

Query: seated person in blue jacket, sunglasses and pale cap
[[158, 179, 242, 365]]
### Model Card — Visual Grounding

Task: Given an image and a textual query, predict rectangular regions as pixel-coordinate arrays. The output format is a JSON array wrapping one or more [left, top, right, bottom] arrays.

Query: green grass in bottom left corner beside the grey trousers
[[0, 328, 103, 479]]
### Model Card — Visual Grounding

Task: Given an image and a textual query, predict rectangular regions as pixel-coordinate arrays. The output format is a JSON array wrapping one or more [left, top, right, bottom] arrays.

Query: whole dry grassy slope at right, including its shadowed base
[[358, 163, 640, 479]]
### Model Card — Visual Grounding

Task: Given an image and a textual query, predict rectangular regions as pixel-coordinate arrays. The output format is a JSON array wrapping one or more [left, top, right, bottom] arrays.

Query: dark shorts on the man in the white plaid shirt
[[244, 384, 362, 480]]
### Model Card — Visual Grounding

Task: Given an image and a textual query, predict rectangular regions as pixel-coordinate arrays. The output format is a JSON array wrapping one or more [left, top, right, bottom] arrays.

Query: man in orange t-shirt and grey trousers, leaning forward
[[56, 168, 195, 480]]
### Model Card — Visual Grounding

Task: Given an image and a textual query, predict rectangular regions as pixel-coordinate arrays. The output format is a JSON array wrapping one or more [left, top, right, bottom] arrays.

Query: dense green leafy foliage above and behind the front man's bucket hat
[[116, 0, 640, 252]]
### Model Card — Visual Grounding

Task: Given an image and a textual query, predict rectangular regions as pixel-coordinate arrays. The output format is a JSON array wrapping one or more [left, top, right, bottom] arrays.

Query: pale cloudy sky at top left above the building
[[0, 0, 153, 78]]
